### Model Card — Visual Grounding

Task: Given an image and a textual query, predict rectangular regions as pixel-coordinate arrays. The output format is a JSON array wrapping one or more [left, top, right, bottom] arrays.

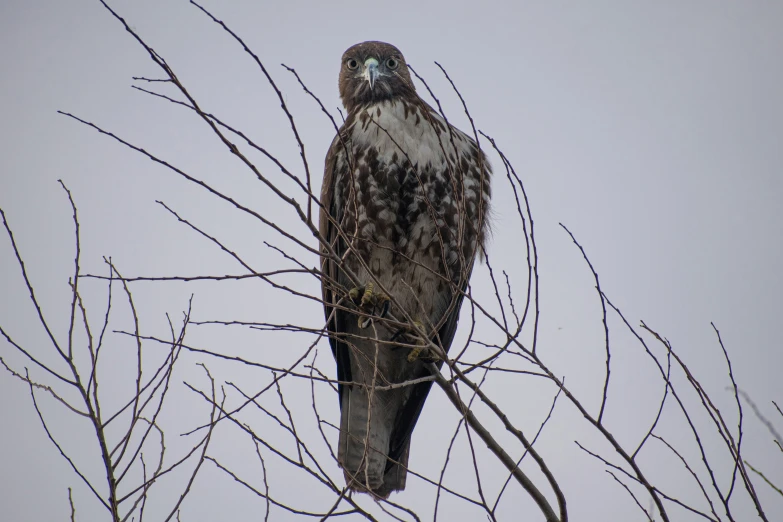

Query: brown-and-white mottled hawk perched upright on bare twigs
[[320, 42, 491, 498]]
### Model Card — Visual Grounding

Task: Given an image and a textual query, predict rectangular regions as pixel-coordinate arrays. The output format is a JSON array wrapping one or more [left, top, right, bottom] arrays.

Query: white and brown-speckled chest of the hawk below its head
[[335, 103, 456, 249]]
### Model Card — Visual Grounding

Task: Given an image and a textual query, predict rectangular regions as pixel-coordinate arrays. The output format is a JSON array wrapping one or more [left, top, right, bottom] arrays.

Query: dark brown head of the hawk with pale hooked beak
[[340, 42, 415, 112]]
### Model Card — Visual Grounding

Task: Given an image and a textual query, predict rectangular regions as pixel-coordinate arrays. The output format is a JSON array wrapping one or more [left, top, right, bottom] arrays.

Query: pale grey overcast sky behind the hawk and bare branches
[[0, 0, 783, 522]]
